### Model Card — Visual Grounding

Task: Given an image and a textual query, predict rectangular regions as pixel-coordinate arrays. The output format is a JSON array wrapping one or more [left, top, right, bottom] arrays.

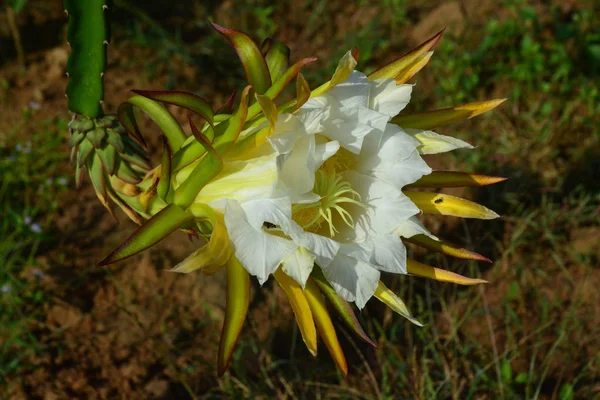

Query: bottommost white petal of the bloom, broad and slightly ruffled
[[321, 254, 381, 308]]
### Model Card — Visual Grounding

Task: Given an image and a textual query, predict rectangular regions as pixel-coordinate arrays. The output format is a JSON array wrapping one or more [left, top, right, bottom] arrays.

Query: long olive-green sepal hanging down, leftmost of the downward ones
[[217, 256, 250, 376]]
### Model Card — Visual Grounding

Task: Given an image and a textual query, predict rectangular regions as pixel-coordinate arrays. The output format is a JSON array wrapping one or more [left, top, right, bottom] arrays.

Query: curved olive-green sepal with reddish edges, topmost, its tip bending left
[[210, 22, 271, 94]]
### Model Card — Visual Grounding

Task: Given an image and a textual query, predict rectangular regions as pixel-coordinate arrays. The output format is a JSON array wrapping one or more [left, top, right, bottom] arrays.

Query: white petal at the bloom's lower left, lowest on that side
[[225, 200, 298, 285]]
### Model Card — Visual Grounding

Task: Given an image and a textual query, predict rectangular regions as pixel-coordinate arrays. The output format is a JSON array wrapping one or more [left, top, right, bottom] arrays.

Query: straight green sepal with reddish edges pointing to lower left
[[98, 204, 194, 266]]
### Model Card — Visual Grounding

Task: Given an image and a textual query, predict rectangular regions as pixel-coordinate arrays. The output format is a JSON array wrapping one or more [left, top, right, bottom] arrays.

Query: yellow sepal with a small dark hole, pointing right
[[403, 192, 499, 219]]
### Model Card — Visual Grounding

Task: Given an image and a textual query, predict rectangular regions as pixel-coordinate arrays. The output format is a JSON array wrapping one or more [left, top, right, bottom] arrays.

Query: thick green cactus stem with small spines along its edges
[[64, 0, 112, 118]]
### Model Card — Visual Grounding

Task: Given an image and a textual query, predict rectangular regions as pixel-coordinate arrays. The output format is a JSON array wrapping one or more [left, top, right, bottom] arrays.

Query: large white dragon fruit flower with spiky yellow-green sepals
[[95, 24, 504, 375]]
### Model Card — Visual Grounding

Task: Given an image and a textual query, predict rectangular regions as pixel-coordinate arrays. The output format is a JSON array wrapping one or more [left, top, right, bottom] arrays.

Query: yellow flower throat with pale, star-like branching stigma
[[292, 169, 365, 238]]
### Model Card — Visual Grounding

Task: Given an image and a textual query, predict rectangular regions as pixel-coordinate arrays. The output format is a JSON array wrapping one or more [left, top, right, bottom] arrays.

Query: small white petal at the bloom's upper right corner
[[369, 79, 413, 118]]
